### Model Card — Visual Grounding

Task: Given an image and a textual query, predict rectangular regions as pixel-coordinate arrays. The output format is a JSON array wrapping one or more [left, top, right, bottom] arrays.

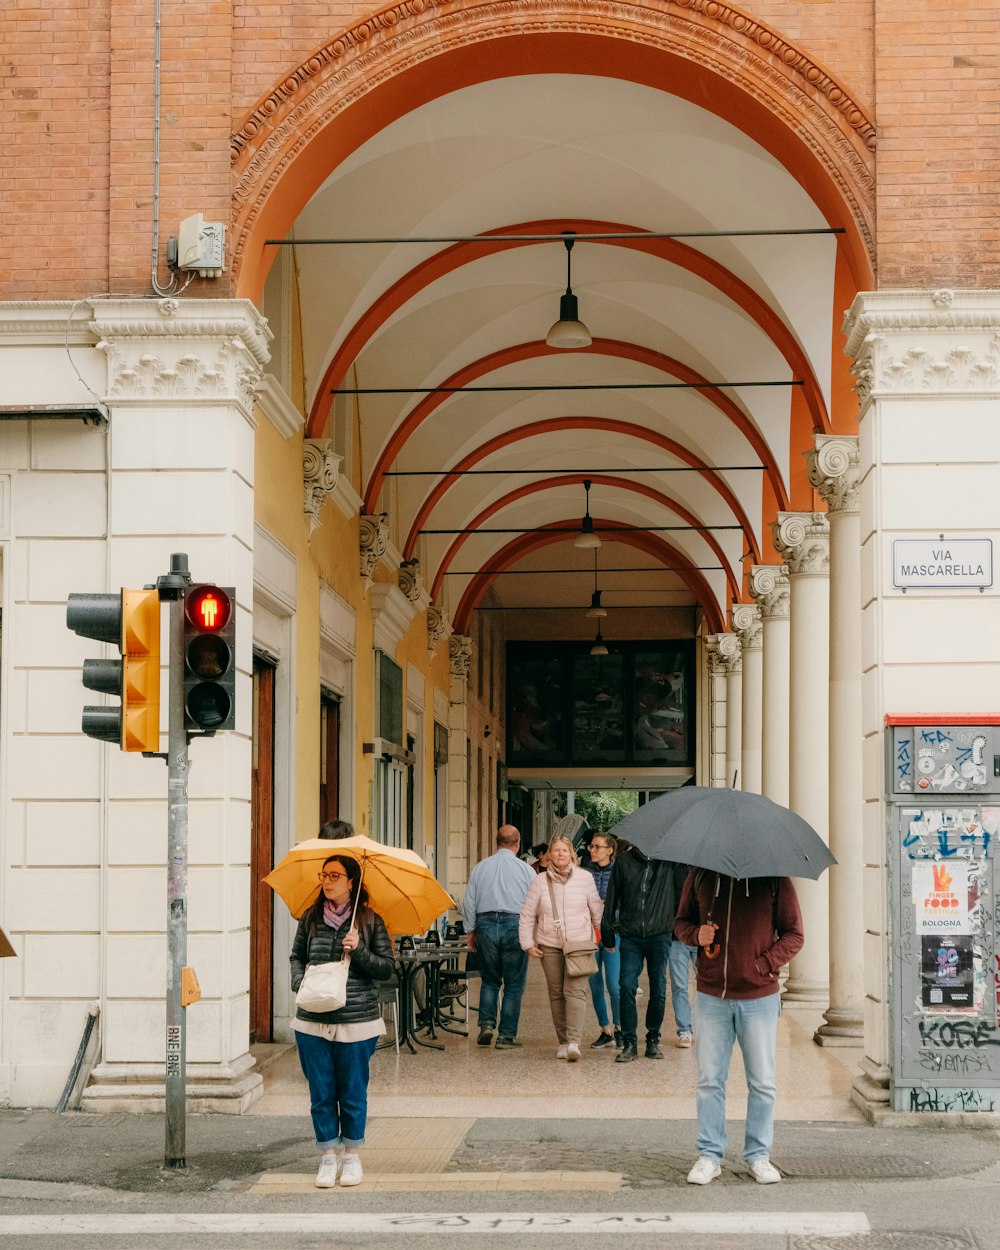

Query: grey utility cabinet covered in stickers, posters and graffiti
[[886, 718, 1000, 1113]]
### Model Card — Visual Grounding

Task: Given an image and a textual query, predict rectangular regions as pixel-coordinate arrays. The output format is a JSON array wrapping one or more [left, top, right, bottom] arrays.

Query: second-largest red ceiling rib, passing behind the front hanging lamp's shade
[[364, 339, 788, 513]]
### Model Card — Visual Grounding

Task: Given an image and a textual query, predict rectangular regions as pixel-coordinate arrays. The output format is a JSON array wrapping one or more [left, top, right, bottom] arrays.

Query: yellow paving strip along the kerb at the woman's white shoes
[[248, 1170, 621, 1194]]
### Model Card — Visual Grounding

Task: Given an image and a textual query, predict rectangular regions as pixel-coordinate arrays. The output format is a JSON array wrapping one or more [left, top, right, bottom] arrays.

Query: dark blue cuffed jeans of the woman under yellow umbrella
[[295, 1031, 379, 1150]]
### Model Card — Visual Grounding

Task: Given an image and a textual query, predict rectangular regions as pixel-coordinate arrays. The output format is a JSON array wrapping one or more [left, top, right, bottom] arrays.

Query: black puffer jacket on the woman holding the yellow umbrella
[[290, 908, 396, 1024]]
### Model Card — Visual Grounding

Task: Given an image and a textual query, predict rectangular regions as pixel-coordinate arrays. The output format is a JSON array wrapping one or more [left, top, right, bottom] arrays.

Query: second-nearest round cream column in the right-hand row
[[773, 513, 830, 1006]]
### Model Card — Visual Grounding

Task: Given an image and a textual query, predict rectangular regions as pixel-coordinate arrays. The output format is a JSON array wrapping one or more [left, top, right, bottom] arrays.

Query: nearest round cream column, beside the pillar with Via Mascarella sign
[[809, 435, 865, 1046]]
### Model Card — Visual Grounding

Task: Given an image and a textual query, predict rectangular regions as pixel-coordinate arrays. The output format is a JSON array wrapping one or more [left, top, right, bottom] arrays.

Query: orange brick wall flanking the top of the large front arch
[[0, 0, 1000, 299]]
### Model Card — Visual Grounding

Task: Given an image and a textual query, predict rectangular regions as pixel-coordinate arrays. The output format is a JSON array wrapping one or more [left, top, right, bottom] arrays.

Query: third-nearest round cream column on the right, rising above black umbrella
[[750, 564, 791, 808]]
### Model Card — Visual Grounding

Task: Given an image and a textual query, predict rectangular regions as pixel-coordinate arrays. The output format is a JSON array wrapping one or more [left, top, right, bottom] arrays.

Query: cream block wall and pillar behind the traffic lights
[[0, 301, 270, 1106]]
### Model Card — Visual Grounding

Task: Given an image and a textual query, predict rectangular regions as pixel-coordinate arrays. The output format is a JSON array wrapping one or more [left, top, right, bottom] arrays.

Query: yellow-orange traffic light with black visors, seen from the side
[[66, 590, 160, 751]]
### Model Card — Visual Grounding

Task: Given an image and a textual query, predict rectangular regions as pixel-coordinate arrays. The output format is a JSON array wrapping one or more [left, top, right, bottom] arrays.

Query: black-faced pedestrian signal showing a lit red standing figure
[[184, 585, 236, 734]]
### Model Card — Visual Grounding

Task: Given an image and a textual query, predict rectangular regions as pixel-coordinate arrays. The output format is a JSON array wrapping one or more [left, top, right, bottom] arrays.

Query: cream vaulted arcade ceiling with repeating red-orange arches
[[278, 73, 841, 639]]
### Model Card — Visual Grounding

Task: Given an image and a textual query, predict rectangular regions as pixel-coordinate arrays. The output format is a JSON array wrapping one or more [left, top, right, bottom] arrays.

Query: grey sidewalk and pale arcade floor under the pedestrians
[[0, 965, 905, 1196]]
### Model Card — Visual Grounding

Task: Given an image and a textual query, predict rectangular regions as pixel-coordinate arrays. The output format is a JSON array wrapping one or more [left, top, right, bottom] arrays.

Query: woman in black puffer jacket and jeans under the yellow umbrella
[[291, 855, 396, 1189]]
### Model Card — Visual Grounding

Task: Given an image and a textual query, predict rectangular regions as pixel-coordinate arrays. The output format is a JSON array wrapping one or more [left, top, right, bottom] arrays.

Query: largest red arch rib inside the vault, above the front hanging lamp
[[306, 218, 830, 439]]
